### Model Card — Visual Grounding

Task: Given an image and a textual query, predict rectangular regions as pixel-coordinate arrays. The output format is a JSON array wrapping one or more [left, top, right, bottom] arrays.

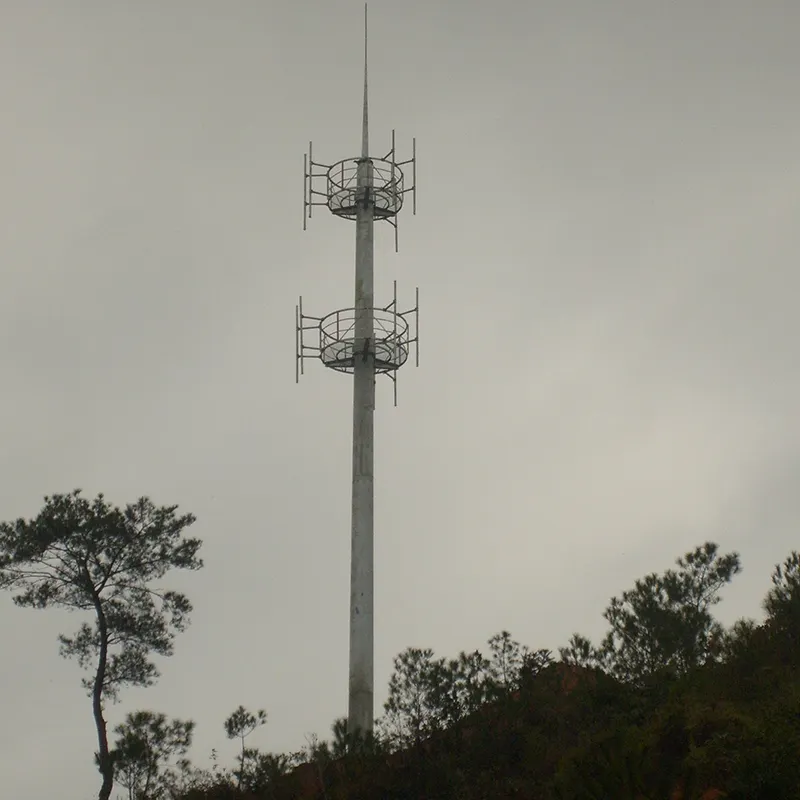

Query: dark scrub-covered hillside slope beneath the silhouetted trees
[[181, 604, 800, 800]]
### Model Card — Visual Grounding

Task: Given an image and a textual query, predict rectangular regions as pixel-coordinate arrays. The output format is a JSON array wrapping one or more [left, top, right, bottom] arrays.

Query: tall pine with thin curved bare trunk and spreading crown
[[0, 490, 202, 800]]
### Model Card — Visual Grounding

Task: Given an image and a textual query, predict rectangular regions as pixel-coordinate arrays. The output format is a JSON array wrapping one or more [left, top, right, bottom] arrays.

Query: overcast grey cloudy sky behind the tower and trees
[[0, 0, 800, 800]]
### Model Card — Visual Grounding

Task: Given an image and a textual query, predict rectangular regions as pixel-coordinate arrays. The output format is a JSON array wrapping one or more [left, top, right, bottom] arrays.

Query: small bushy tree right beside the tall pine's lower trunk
[[111, 711, 195, 800]]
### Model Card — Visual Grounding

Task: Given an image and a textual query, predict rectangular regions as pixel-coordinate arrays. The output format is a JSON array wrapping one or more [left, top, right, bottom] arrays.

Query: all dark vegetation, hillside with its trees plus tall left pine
[[0, 491, 800, 800]]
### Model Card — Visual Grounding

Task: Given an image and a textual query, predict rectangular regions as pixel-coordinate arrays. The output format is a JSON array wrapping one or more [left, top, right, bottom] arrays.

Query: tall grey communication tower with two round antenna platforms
[[295, 5, 419, 733]]
